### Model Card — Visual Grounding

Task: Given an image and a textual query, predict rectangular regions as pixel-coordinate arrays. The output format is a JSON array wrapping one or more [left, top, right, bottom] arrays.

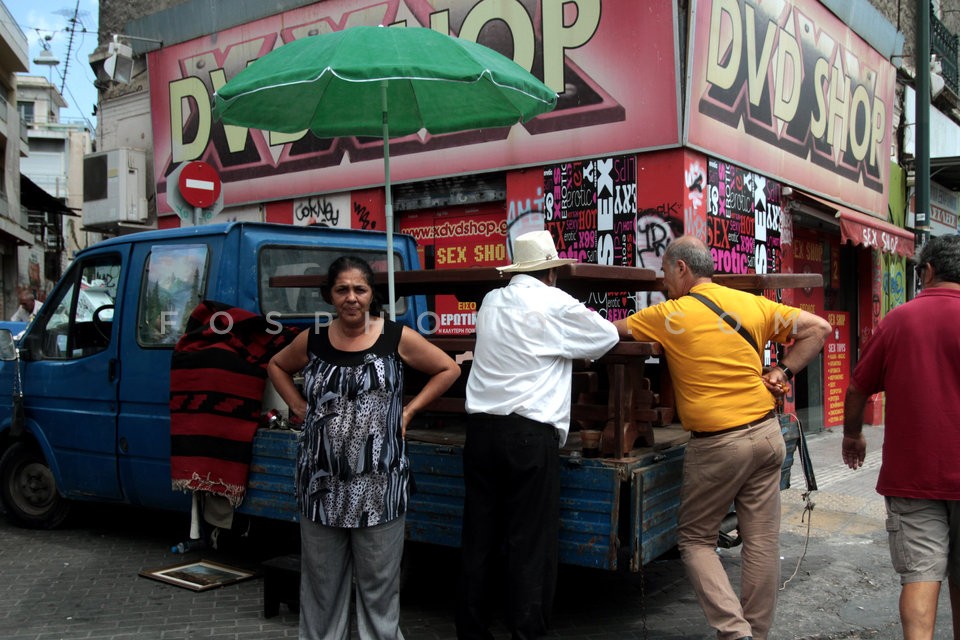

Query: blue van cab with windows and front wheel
[[0, 222, 423, 528]]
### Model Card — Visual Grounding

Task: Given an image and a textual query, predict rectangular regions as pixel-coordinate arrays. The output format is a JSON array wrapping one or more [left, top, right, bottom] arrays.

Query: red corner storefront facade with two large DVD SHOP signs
[[148, 0, 912, 428]]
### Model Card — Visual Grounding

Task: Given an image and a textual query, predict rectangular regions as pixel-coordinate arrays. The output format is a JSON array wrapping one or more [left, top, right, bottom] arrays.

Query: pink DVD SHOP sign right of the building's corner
[[685, 0, 896, 218]]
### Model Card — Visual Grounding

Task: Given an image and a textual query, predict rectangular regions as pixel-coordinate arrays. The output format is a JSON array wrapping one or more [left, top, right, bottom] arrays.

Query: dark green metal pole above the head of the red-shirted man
[[914, 0, 930, 230]]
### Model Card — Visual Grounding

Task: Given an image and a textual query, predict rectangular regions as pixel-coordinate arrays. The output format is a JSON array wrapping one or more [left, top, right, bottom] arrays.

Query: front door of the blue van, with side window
[[21, 246, 129, 500]]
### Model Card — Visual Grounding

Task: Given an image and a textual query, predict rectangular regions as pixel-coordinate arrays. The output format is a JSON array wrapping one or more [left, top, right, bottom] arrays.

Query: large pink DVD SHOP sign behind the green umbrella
[[148, 0, 680, 218]]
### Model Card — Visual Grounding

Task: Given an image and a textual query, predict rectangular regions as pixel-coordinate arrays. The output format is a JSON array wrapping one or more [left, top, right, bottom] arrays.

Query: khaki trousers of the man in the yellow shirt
[[678, 417, 786, 640]]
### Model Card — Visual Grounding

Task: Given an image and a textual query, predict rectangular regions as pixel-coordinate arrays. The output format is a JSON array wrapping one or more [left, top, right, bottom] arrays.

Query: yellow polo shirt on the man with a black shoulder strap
[[627, 282, 800, 431]]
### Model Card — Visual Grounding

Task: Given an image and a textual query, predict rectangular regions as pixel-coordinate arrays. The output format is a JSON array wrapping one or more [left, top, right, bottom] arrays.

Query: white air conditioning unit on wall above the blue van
[[83, 149, 147, 228]]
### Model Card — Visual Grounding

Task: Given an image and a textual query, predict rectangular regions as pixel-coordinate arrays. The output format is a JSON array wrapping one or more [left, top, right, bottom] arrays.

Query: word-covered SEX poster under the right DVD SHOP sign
[[707, 158, 783, 274]]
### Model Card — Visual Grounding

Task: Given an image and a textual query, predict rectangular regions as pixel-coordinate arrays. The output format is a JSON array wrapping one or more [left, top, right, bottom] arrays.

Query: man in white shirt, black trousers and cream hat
[[457, 231, 619, 639]]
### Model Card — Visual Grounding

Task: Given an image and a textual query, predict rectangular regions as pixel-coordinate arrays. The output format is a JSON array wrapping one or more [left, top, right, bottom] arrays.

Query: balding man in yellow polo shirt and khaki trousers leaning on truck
[[614, 236, 830, 640]]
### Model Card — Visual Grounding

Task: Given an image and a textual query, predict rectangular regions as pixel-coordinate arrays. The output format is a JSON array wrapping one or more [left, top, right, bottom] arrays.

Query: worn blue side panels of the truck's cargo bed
[[238, 417, 799, 572]]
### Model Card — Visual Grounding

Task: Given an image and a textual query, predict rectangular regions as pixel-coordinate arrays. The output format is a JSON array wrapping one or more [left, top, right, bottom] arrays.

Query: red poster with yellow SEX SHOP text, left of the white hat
[[398, 205, 510, 336]]
